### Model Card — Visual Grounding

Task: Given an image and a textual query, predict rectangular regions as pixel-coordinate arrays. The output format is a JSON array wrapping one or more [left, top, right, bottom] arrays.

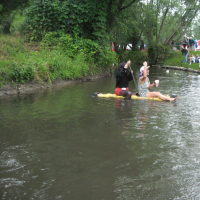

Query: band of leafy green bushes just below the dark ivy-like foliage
[[42, 31, 117, 67]]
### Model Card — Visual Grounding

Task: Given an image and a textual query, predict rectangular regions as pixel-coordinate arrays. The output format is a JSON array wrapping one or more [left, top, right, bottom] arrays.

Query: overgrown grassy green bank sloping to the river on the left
[[0, 35, 118, 86]]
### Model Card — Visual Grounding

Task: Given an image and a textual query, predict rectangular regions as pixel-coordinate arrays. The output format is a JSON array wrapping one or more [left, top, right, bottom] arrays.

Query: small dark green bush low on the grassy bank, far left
[[9, 63, 34, 83]]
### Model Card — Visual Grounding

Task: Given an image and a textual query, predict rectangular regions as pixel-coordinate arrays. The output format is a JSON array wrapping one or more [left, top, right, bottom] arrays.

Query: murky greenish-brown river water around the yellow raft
[[0, 67, 200, 200]]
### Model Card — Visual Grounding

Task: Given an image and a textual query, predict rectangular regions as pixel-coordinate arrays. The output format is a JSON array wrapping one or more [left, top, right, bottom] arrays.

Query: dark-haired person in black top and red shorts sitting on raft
[[115, 60, 139, 100]]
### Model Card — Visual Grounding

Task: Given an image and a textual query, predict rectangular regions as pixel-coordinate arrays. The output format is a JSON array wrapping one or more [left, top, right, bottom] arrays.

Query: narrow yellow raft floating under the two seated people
[[94, 92, 177, 101]]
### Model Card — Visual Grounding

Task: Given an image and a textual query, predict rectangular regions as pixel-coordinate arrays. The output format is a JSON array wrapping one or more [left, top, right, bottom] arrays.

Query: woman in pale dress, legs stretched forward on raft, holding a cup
[[138, 61, 177, 102]]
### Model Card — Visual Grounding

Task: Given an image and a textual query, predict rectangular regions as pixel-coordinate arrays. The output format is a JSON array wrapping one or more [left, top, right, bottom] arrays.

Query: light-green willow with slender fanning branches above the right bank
[[138, 0, 199, 64]]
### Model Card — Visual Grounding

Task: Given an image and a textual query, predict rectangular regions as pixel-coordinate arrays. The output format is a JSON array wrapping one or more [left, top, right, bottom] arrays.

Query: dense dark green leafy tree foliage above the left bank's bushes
[[25, 0, 108, 41]]
